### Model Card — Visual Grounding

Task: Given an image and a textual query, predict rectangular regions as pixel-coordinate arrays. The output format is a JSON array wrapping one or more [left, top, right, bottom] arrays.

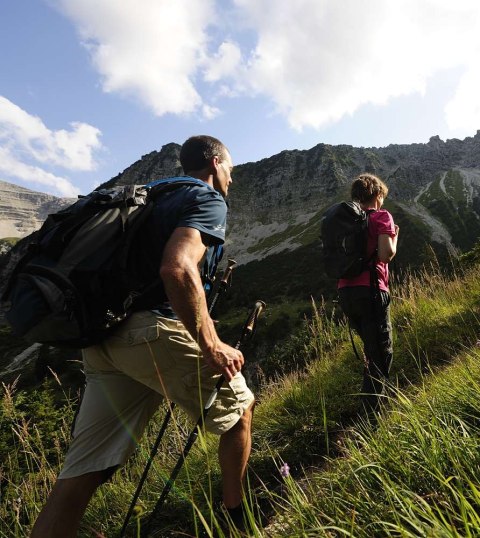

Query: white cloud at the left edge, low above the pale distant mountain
[[0, 96, 101, 196]]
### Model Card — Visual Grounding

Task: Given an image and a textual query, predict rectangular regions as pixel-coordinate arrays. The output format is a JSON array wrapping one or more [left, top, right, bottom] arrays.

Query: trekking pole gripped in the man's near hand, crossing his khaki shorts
[[148, 301, 266, 525]]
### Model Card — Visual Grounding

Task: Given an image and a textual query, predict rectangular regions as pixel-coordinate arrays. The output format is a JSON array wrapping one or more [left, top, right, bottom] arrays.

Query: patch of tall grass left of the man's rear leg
[[0, 378, 77, 538]]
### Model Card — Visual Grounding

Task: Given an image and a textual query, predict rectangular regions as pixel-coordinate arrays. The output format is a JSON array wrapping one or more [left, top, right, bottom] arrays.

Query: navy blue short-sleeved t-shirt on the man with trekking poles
[[135, 177, 227, 317]]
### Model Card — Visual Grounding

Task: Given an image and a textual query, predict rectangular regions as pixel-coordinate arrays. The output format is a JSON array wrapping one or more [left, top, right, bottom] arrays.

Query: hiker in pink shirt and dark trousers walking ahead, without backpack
[[338, 174, 399, 411]]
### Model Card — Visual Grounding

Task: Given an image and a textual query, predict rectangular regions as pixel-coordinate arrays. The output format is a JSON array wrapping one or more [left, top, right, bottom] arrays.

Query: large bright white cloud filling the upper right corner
[[231, 0, 480, 129]]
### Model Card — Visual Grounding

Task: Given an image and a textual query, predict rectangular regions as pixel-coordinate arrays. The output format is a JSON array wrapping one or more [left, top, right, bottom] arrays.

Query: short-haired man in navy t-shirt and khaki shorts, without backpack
[[31, 136, 254, 538]]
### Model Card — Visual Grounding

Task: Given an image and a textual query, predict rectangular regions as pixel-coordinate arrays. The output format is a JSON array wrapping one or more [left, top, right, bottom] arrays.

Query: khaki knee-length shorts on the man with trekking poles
[[59, 312, 254, 478]]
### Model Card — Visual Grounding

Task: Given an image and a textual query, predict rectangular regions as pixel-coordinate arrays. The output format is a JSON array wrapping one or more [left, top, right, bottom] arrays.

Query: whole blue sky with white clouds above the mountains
[[0, 0, 480, 196]]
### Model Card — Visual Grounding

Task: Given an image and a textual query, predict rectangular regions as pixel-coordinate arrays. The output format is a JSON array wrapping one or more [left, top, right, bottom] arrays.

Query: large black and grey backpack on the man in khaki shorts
[[2, 178, 205, 348]]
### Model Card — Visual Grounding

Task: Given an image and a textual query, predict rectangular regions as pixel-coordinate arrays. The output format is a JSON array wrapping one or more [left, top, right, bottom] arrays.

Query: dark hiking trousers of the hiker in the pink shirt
[[338, 286, 393, 410]]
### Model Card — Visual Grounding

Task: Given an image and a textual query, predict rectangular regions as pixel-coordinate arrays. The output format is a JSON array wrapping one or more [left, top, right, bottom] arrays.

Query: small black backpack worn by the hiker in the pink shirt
[[321, 202, 375, 279]]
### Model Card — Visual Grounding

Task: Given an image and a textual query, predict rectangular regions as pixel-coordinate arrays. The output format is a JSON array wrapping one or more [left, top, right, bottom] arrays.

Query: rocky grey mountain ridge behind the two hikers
[[0, 131, 480, 272]]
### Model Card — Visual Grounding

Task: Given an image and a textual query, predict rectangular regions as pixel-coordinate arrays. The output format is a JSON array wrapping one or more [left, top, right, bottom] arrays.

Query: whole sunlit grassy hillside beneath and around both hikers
[[0, 258, 480, 537]]
